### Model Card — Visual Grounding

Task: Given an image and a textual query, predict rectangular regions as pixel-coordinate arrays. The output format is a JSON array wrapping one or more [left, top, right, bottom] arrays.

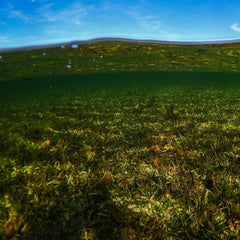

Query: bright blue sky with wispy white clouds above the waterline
[[0, 0, 240, 48]]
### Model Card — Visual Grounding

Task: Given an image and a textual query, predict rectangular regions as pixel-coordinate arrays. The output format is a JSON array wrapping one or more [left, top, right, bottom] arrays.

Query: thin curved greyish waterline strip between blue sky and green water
[[0, 37, 240, 53]]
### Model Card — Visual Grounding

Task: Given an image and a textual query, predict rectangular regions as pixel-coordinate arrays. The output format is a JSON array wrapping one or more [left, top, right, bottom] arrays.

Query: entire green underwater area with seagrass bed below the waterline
[[0, 41, 240, 240]]
